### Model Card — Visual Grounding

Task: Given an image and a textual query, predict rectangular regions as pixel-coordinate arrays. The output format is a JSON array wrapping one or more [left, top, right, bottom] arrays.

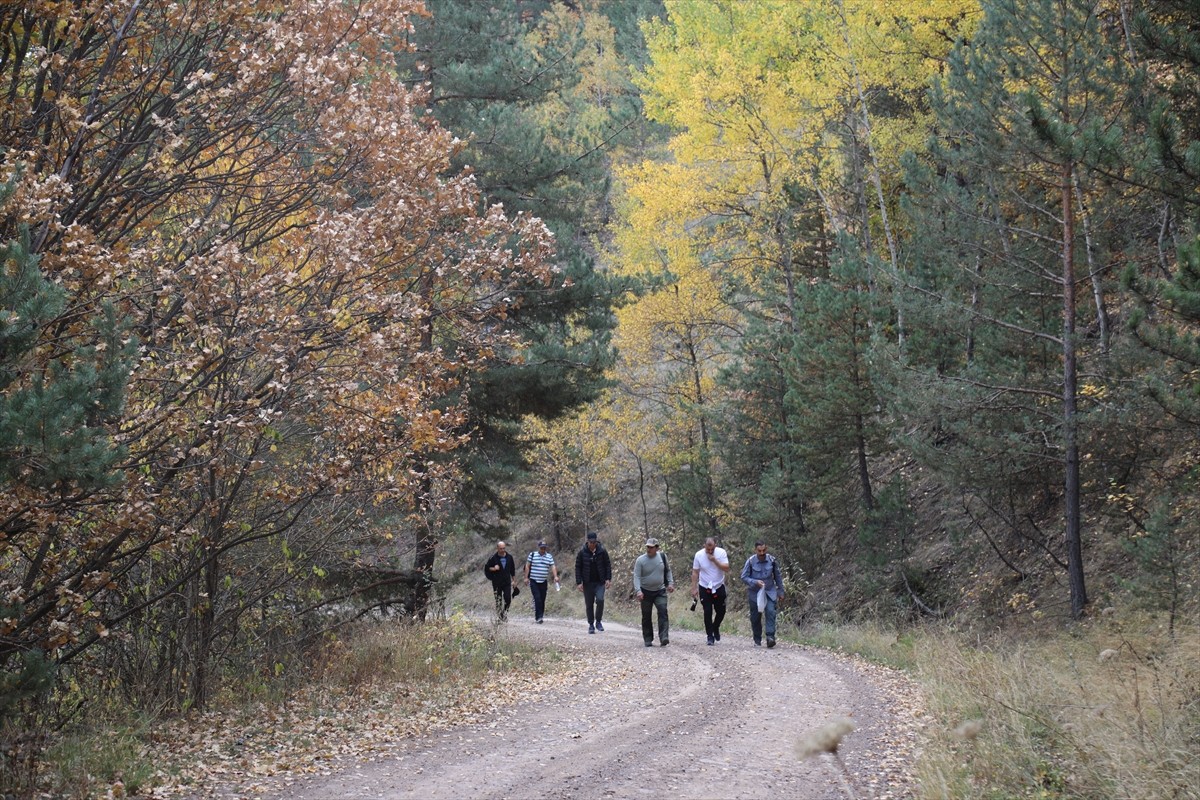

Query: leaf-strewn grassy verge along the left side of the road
[[0, 613, 565, 800]]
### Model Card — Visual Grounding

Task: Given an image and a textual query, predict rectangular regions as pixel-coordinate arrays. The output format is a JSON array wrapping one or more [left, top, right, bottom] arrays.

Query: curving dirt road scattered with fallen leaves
[[248, 618, 919, 800]]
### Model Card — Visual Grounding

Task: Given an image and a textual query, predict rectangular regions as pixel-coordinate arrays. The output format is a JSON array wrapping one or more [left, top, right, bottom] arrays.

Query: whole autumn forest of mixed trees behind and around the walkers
[[0, 0, 1200, 798]]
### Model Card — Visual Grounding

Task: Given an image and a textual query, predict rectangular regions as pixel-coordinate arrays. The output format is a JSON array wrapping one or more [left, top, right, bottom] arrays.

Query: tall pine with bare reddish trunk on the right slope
[[894, 0, 1124, 616]]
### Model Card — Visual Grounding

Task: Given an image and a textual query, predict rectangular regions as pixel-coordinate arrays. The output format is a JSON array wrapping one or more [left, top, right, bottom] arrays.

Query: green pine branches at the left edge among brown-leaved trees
[[0, 187, 133, 711]]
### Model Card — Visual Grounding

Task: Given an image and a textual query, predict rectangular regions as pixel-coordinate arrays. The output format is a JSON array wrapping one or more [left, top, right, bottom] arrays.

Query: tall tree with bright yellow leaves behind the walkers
[[600, 0, 977, 544]]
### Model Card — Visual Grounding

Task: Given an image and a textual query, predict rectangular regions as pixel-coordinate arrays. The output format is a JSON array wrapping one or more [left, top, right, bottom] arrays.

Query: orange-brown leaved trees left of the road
[[0, 0, 553, 704]]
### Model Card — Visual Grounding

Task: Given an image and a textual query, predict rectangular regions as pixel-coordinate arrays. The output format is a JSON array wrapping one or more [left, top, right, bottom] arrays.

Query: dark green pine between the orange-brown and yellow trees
[[398, 0, 656, 507]]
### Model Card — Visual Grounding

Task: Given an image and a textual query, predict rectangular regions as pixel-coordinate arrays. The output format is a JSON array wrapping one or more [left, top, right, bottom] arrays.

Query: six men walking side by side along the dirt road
[[484, 531, 784, 648]]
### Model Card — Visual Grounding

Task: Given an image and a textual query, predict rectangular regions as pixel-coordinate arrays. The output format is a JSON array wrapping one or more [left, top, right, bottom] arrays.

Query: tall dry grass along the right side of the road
[[801, 613, 1200, 800]]
